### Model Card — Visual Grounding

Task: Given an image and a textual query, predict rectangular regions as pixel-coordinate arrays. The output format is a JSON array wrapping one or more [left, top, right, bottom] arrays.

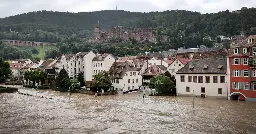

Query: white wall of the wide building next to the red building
[[176, 74, 228, 97]]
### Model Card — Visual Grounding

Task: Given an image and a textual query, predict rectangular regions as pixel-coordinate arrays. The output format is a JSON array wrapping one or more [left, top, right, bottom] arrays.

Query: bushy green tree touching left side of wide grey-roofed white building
[[149, 75, 175, 95]]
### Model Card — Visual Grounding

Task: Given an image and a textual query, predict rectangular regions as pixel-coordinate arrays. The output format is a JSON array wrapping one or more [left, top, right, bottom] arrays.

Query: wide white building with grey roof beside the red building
[[176, 58, 228, 97]]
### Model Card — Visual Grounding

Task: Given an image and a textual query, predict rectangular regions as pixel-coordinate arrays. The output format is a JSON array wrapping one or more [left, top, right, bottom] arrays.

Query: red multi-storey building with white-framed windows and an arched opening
[[227, 35, 256, 101]]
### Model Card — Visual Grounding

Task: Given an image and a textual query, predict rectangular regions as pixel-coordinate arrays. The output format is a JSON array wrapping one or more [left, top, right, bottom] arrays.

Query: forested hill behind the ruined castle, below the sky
[[0, 8, 256, 47]]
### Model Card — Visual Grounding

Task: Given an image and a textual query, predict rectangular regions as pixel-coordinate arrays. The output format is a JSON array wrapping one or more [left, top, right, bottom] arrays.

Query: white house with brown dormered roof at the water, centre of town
[[109, 62, 142, 91]]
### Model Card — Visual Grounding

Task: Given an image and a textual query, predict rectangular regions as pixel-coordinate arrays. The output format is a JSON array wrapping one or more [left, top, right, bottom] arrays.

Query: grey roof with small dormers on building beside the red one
[[177, 57, 227, 74]]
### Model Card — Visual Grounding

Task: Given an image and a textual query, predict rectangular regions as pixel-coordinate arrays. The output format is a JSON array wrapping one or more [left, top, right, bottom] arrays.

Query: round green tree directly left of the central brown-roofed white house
[[92, 71, 112, 91]]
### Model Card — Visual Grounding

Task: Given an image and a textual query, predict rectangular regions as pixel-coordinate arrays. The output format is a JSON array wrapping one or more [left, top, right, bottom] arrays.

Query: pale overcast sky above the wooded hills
[[0, 0, 256, 18]]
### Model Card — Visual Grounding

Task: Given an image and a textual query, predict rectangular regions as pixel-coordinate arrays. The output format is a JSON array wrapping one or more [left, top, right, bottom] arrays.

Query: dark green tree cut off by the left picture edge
[[0, 57, 12, 83]]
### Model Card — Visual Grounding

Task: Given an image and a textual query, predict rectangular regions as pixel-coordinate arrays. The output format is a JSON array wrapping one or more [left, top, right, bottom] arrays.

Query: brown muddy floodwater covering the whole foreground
[[0, 89, 256, 134]]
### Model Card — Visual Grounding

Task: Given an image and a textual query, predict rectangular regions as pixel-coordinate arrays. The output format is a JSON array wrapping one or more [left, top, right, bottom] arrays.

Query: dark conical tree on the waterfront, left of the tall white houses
[[56, 69, 71, 92]]
